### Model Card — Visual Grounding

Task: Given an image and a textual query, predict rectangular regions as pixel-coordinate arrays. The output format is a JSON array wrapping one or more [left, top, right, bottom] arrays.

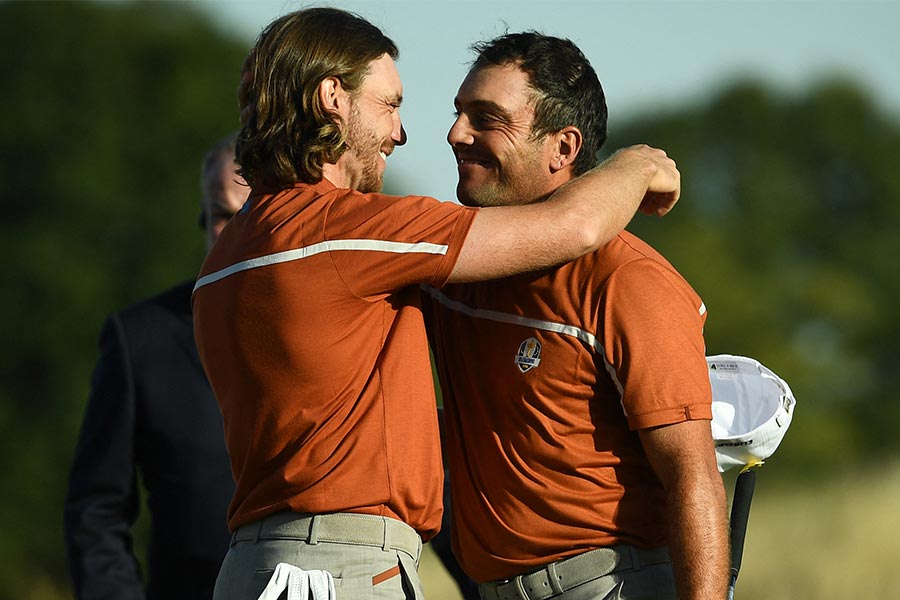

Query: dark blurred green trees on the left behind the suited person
[[0, 2, 248, 598]]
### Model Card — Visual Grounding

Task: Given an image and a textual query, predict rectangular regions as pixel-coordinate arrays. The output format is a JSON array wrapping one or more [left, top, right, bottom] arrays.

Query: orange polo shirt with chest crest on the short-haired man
[[423, 232, 712, 581]]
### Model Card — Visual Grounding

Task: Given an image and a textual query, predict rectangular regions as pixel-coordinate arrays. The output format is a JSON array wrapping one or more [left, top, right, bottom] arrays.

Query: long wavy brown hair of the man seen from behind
[[237, 8, 399, 190]]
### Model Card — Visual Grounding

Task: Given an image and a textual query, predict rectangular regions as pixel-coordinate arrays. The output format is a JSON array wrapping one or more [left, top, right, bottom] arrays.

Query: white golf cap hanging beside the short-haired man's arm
[[706, 354, 797, 471]]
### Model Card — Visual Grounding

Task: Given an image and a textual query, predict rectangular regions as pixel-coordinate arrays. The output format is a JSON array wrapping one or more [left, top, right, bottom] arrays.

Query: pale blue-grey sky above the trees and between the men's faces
[[196, 0, 900, 200]]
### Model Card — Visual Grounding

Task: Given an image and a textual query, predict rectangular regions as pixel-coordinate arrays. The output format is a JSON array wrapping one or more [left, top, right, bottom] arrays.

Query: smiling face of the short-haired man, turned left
[[447, 65, 558, 206]]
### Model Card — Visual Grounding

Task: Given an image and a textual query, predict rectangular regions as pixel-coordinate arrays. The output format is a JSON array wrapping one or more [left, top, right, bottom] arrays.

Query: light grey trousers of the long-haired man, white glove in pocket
[[213, 513, 423, 600]]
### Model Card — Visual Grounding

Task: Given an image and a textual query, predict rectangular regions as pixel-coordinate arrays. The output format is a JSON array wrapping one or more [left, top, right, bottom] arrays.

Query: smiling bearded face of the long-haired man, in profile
[[341, 54, 406, 193]]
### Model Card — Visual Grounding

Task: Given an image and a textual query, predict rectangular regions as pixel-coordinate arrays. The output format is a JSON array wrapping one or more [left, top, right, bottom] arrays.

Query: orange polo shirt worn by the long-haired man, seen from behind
[[193, 180, 476, 540]]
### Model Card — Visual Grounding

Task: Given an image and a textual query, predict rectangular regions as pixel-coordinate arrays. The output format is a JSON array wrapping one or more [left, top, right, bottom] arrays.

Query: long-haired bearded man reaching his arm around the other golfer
[[193, 8, 680, 600]]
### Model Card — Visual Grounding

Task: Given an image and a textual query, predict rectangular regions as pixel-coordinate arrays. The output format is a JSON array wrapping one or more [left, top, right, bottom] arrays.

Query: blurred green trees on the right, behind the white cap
[[609, 79, 900, 476]]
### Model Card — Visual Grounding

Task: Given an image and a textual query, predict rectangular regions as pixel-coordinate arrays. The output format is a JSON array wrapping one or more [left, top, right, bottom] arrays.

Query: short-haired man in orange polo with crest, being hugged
[[424, 32, 728, 600]]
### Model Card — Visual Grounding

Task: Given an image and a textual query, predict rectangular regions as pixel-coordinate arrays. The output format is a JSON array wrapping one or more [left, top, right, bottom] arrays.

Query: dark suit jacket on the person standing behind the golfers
[[65, 282, 234, 600]]
